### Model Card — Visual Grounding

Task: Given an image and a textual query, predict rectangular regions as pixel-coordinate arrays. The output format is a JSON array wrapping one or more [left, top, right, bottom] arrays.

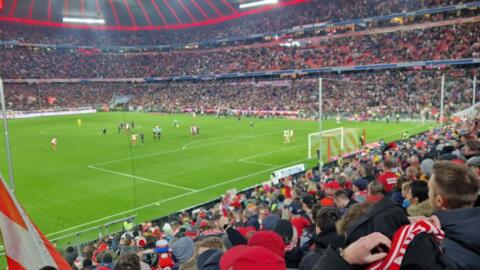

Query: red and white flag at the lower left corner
[[0, 179, 71, 270]]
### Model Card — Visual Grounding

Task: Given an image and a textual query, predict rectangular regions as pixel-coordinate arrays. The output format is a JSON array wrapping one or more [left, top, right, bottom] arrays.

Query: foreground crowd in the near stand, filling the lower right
[[59, 114, 480, 270]]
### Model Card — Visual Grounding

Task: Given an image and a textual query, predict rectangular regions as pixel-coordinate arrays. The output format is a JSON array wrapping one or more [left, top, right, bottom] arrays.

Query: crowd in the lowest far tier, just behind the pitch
[[5, 68, 480, 118]]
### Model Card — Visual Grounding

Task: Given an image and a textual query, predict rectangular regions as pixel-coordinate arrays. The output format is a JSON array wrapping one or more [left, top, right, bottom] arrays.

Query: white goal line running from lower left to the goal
[[46, 158, 306, 237]]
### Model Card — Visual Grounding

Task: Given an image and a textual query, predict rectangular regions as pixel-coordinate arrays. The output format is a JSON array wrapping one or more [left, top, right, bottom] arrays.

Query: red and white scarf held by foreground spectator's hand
[[367, 220, 445, 270]]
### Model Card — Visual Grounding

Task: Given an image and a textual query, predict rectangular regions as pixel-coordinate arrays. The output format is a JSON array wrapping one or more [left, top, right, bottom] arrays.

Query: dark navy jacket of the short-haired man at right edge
[[434, 207, 480, 269]]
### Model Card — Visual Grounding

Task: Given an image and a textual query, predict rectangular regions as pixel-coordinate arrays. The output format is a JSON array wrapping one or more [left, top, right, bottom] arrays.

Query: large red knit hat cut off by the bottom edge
[[220, 246, 287, 270]]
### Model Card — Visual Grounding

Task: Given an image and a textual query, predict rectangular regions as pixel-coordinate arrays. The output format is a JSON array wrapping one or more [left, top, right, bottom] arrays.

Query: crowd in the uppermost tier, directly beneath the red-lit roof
[[0, 0, 475, 46]]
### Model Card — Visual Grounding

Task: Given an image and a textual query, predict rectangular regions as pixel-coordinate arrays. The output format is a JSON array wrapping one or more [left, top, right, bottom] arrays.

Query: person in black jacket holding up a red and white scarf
[[315, 197, 451, 269]]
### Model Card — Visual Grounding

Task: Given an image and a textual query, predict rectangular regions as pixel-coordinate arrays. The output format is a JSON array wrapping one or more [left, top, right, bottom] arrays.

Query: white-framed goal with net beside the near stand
[[308, 127, 365, 161]]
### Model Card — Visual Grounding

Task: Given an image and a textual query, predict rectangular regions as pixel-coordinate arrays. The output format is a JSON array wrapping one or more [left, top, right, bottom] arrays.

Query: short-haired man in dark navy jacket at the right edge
[[429, 161, 480, 269]]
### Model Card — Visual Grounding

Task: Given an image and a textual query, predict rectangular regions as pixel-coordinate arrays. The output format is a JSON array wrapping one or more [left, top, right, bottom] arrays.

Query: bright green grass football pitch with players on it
[[0, 113, 428, 260]]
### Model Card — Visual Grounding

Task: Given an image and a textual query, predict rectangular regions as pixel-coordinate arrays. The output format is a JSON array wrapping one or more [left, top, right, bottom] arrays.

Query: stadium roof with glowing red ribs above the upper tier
[[0, 0, 308, 30]]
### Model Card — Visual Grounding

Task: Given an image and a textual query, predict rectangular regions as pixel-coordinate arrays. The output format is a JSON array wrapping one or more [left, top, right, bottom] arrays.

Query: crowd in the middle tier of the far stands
[[0, 23, 480, 79]]
